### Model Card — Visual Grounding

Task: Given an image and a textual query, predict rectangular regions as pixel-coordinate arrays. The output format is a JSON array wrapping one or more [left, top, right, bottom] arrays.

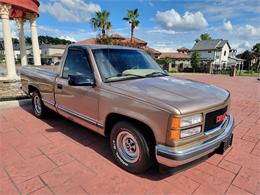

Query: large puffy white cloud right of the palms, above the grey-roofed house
[[155, 9, 208, 31]]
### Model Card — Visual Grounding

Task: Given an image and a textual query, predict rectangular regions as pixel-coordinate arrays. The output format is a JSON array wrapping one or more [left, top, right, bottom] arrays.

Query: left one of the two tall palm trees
[[90, 10, 112, 38]]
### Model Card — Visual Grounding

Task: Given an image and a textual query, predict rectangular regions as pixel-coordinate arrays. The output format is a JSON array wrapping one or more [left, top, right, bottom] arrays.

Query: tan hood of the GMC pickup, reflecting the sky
[[111, 76, 229, 114]]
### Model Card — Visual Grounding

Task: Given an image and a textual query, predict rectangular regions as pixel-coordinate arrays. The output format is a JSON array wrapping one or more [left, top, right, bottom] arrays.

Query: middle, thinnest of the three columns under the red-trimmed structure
[[16, 18, 28, 66]]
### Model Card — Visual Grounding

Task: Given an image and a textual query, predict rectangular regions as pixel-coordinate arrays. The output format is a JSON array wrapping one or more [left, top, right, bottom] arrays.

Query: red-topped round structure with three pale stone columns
[[0, 0, 41, 79]]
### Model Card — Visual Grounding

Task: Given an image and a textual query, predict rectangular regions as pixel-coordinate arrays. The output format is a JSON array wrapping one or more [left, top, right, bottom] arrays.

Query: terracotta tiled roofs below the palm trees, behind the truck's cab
[[77, 34, 161, 58]]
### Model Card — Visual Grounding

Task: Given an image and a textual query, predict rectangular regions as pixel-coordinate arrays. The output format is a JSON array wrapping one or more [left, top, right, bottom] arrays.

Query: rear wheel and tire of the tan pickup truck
[[32, 91, 47, 119]]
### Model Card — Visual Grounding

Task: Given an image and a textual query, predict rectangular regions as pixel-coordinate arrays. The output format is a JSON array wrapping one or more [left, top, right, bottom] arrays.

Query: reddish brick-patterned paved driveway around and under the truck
[[0, 75, 260, 194]]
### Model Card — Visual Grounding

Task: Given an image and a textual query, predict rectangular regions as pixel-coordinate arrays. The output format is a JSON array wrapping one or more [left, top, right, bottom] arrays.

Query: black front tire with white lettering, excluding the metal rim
[[110, 121, 152, 173]]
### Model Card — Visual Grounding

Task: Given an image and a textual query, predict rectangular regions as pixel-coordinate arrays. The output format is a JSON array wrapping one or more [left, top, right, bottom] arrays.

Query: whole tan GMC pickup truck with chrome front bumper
[[21, 44, 234, 173]]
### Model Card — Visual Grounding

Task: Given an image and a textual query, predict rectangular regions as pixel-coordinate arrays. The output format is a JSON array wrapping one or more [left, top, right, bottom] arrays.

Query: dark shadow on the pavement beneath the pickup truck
[[21, 105, 208, 181]]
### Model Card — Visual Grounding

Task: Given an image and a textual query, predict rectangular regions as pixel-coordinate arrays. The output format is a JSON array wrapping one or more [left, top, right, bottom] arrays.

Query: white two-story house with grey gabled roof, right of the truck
[[191, 39, 231, 69]]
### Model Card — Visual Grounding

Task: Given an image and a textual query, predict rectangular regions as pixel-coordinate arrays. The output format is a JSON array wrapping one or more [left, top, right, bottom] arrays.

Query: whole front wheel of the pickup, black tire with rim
[[110, 121, 154, 173]]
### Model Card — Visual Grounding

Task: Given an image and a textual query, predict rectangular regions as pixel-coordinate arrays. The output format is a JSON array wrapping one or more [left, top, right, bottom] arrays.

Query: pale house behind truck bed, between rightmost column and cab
[[40, 44, 67, 65]]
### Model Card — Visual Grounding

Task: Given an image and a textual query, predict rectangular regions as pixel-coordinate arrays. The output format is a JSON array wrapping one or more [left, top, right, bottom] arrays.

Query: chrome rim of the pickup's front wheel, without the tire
[[116, 131, 140, 163]]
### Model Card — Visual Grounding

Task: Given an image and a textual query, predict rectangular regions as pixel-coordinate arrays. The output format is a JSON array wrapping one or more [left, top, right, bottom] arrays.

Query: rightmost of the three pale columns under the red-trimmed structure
[[29, 14, 41, 66]]
